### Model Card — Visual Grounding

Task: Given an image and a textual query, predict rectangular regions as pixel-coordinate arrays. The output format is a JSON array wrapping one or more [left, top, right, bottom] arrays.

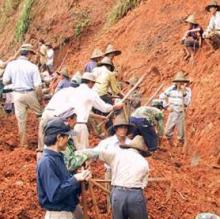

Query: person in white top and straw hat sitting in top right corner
[[203, 0, 220, 49]]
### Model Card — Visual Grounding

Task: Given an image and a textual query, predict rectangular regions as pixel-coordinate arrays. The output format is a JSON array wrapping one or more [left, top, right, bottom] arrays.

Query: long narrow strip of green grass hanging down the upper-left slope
[[15, 0, 34, 41]]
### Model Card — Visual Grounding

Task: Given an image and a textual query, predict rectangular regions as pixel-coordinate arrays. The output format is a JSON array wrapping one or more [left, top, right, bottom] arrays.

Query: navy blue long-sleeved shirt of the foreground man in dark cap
[[37, 149, 80, 212]]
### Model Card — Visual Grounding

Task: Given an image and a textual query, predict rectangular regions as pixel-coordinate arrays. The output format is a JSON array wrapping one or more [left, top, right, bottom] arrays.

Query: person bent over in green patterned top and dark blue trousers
[[130, 99, 164, 152]]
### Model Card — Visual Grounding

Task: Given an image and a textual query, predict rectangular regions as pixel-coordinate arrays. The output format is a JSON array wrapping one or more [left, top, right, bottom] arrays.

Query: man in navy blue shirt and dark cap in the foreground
[[37, 118, 92, 219]]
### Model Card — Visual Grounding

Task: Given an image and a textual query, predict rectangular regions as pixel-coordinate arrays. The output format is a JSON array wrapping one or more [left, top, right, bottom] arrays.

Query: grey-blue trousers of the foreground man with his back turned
[[111, 187, 148, 219]]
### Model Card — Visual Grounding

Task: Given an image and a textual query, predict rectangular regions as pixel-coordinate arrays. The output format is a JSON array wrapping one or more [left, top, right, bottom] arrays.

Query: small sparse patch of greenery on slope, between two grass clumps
[[74, 11, 90, 37]]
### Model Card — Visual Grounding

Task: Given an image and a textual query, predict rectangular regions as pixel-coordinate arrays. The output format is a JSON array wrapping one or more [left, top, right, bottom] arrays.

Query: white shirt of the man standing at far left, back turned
[[3, 56, 41, 91]]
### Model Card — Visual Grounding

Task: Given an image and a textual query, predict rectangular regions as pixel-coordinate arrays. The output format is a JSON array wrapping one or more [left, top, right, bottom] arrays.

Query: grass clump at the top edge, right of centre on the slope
[[107, 0, 141, 25]]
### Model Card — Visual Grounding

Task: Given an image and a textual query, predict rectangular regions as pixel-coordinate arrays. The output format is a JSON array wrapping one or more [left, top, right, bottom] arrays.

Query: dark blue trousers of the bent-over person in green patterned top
[[130, 117, 159, 151]]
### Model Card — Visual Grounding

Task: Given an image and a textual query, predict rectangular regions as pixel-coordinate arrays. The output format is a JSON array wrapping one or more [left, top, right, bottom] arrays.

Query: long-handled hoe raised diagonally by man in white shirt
[[98, 66, 159, 127]]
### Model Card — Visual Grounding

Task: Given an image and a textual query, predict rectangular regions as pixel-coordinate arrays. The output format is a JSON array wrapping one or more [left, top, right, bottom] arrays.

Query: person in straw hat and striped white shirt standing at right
[[160, 71, 192, 145]]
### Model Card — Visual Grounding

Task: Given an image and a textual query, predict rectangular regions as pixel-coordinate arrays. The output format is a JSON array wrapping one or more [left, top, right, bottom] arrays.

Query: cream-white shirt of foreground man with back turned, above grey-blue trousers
[[99, 148, 149, 189]]
